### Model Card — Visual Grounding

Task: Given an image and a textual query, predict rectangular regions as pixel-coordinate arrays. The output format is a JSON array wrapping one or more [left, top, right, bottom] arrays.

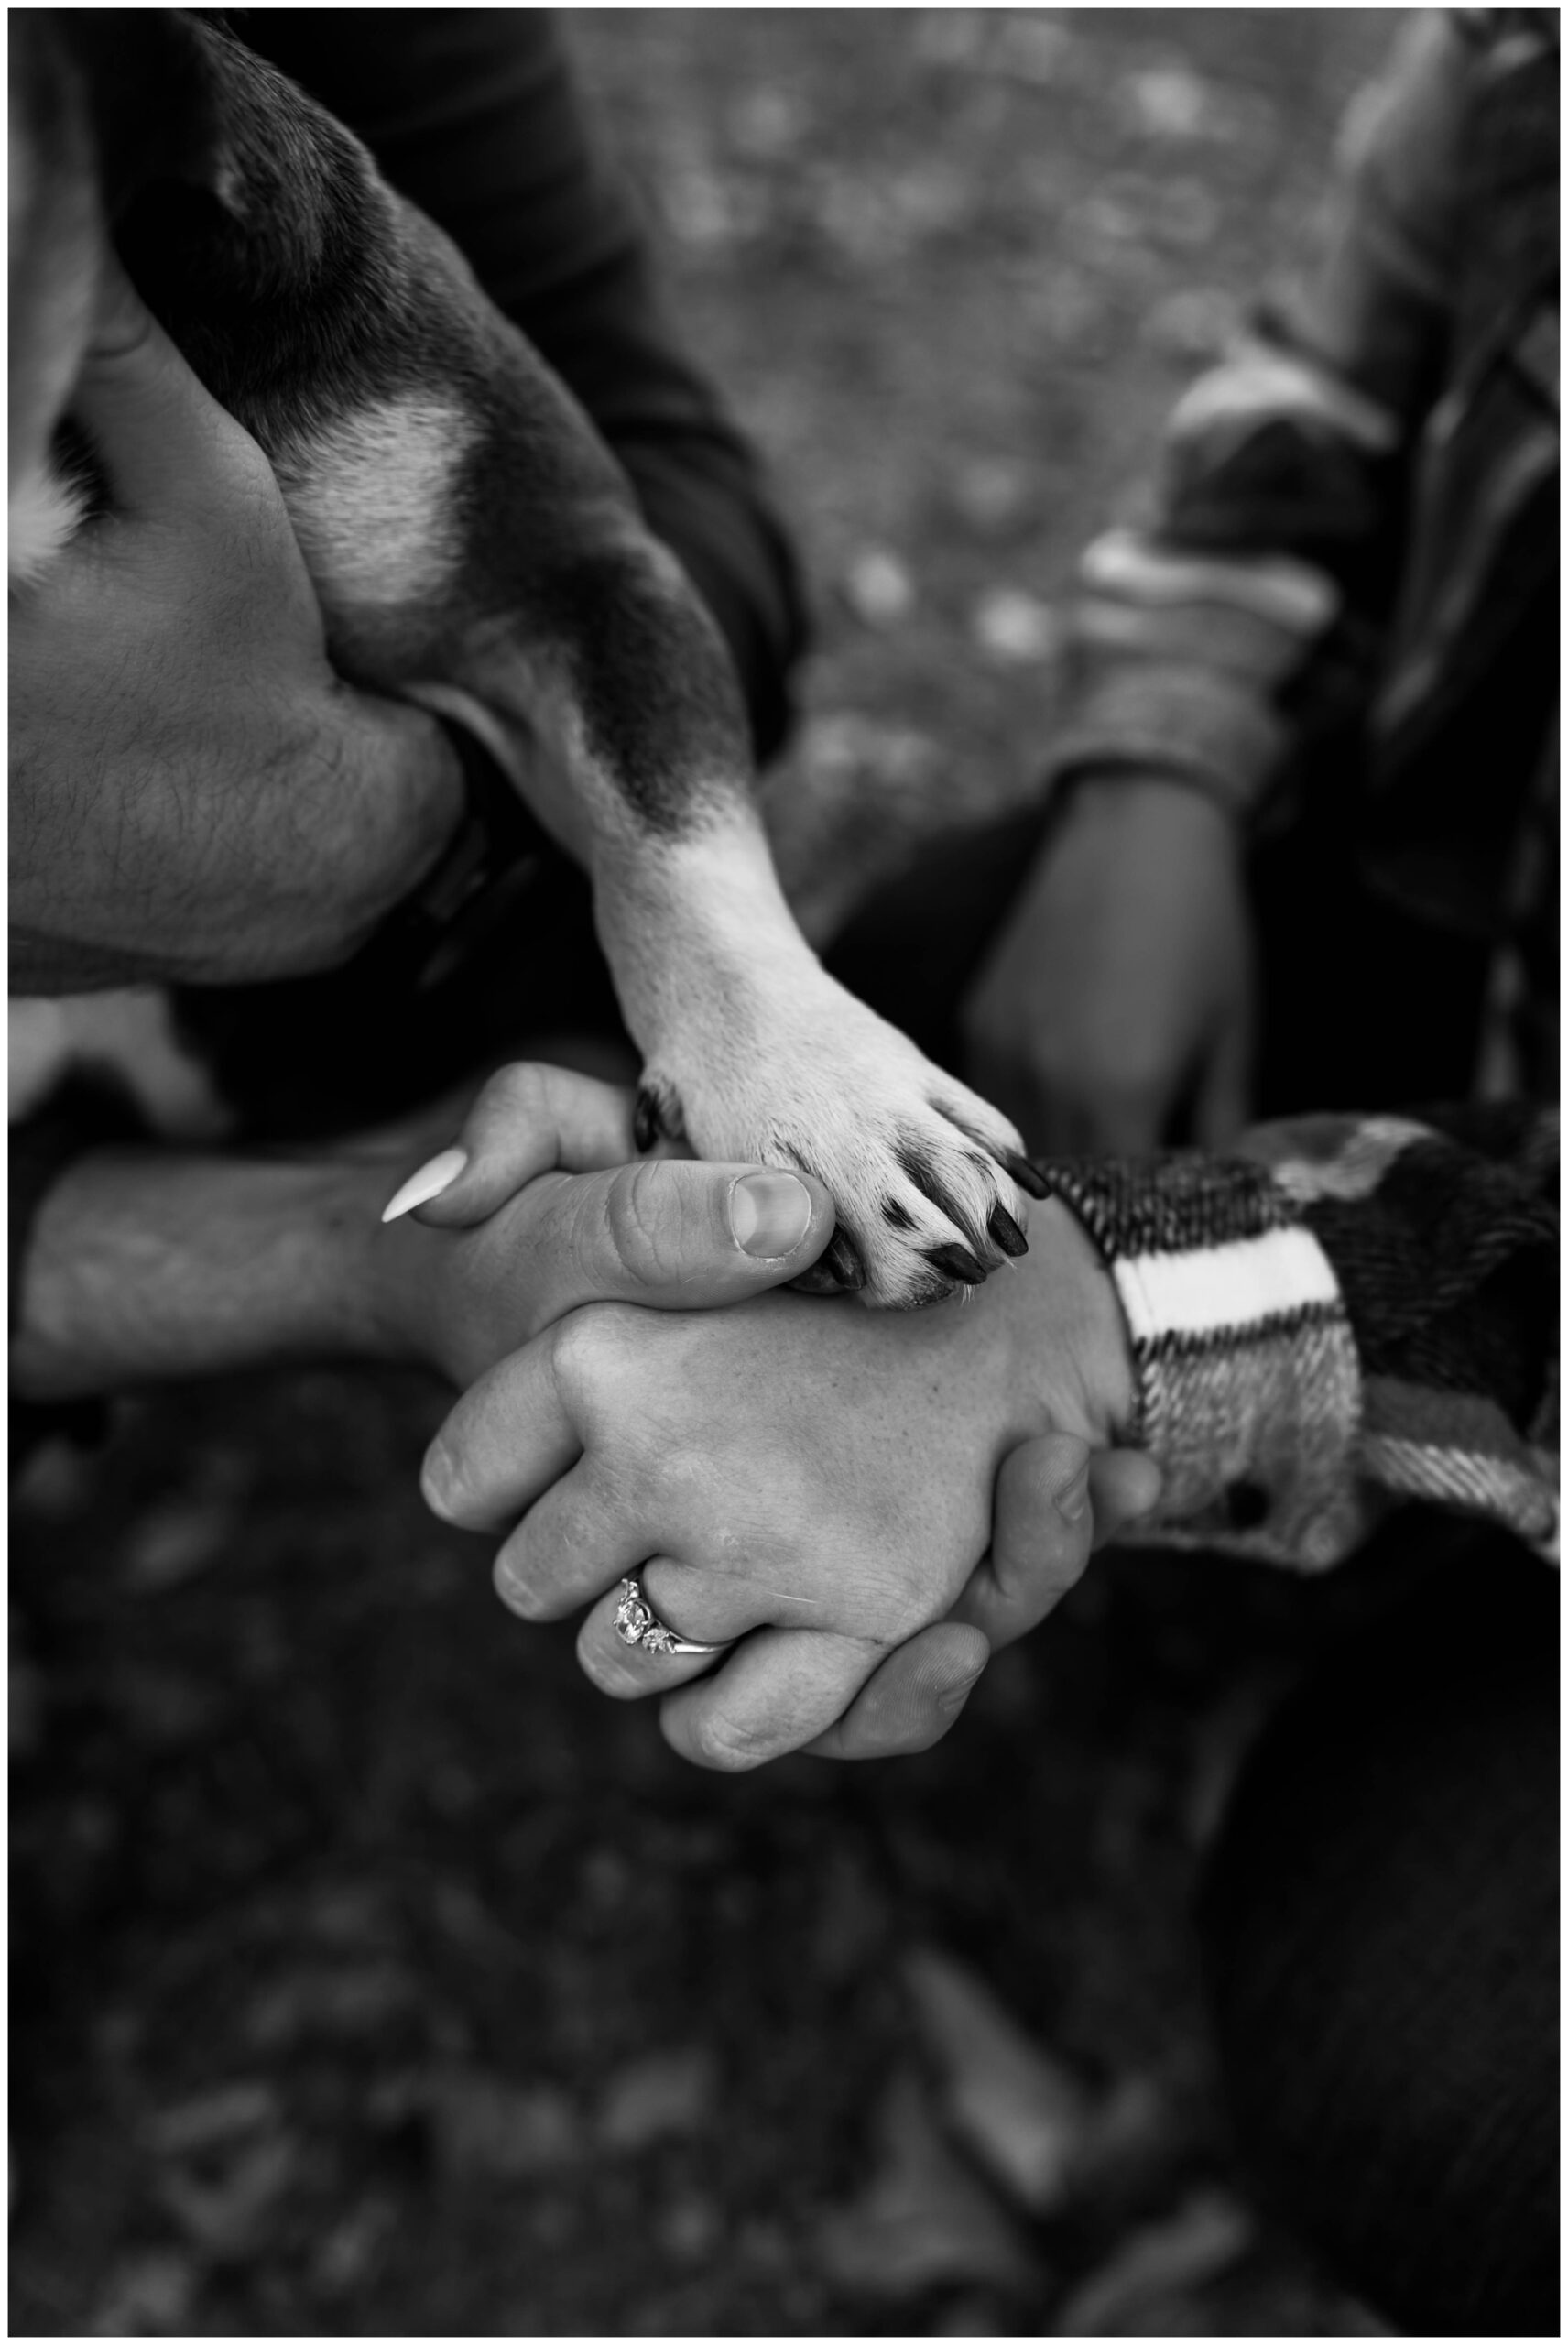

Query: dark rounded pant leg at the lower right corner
[[1200, 1524, 1559, 2336]]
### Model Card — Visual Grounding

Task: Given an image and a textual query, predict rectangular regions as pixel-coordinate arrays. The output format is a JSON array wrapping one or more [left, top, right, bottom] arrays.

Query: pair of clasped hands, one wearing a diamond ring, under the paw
[[384, 1069, 1158, 1768]]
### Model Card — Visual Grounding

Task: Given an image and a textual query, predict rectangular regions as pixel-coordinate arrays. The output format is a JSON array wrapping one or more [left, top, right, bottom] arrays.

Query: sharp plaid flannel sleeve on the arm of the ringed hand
[[1040, 1107, 1559, 1571]]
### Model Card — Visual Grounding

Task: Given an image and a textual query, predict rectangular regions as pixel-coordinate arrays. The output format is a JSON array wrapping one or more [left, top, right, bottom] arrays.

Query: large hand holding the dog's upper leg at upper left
[[9, 272, 462, 994]]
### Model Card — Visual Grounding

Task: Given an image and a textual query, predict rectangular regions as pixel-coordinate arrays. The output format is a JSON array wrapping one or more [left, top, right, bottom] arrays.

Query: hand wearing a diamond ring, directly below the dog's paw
[[424, 1203, 1132, 1768]]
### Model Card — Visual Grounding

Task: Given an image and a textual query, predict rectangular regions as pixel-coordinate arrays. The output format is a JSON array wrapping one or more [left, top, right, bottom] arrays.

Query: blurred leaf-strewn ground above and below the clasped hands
[[12, 9, 1397, 2336]]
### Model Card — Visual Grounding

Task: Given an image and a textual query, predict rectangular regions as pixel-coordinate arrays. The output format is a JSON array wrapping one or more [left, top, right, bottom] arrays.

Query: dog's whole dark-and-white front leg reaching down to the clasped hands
[[9, 9, 1029, 1306]]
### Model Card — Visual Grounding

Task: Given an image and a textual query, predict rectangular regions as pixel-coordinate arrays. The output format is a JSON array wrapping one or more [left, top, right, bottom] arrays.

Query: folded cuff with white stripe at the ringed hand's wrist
[[1040, 1154, 1367, 1571]]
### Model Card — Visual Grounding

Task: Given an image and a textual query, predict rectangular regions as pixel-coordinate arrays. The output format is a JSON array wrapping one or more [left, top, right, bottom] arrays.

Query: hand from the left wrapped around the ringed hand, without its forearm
[[372, 1064, 1158, 1759]]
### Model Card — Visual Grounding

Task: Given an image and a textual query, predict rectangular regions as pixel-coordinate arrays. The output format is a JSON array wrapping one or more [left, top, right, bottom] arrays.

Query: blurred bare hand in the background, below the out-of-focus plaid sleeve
[[965, 774, 1252, 1156]]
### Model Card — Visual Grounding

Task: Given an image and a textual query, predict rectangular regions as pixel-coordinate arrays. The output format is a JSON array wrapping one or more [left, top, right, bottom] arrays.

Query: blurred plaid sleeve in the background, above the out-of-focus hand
[[1048, 12, 1472, 816]]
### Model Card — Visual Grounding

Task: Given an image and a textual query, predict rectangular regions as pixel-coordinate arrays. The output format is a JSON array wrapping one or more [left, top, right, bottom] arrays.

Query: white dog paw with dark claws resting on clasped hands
[[637, 971, 1045, 1311]]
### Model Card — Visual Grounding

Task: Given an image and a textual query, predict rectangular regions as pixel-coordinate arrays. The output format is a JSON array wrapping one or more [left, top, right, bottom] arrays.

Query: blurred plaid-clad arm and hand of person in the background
[[968, 12, 1556, 1149]]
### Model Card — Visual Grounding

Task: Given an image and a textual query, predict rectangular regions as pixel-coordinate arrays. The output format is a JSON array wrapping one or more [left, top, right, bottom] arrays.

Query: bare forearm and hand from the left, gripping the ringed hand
[[12, 1067, 1141, 1759]]
